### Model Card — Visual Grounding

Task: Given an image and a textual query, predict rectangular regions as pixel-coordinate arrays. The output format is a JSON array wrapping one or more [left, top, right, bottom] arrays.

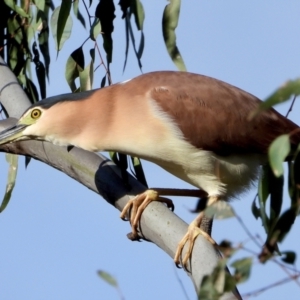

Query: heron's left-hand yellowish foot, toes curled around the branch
[[120, 190, 174, 240]]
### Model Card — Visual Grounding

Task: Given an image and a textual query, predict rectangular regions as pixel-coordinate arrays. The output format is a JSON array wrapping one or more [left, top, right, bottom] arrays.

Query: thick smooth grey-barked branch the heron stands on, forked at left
[[0, 57, 241, 300]]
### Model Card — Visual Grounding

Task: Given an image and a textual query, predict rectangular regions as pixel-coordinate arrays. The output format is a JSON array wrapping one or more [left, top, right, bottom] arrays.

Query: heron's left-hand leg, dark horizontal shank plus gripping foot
[[120, 188, 207, 240]]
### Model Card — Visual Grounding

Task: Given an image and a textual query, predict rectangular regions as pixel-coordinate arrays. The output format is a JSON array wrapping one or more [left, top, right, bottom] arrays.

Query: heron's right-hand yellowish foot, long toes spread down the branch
[[174, 218, 217, 271]]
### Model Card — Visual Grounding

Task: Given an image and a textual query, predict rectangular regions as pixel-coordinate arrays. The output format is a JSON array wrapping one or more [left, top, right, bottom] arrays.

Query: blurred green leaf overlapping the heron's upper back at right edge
[[250, 78, 300, 118]]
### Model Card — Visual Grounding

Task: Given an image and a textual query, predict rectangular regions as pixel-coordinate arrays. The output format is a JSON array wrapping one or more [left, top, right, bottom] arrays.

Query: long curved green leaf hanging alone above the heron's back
[[162, 0, 186, 71]]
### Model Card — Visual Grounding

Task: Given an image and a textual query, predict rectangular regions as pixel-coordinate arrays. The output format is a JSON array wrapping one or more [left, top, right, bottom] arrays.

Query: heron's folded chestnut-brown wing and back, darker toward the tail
[[139, 72, 300, 155]]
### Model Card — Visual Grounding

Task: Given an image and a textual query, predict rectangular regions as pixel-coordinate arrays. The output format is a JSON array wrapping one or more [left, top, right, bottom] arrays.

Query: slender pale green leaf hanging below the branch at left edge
[[0, 153, 18, 213]]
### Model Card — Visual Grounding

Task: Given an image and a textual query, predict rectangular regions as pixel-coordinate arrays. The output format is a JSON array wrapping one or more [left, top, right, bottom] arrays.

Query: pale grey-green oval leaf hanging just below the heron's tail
[[268, 134, 291, 177]]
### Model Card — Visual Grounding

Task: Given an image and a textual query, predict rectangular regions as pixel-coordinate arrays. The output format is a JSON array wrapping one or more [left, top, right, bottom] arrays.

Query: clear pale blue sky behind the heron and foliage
[[0, 0, 300, 300]]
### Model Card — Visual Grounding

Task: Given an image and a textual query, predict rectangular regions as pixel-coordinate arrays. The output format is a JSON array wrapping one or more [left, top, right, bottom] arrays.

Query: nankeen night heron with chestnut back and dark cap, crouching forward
[[0, 72, 300, 266]]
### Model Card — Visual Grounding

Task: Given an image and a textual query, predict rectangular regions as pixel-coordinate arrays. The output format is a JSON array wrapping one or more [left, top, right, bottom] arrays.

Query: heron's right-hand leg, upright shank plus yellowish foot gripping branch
[[174, 196, 219, 269]]
